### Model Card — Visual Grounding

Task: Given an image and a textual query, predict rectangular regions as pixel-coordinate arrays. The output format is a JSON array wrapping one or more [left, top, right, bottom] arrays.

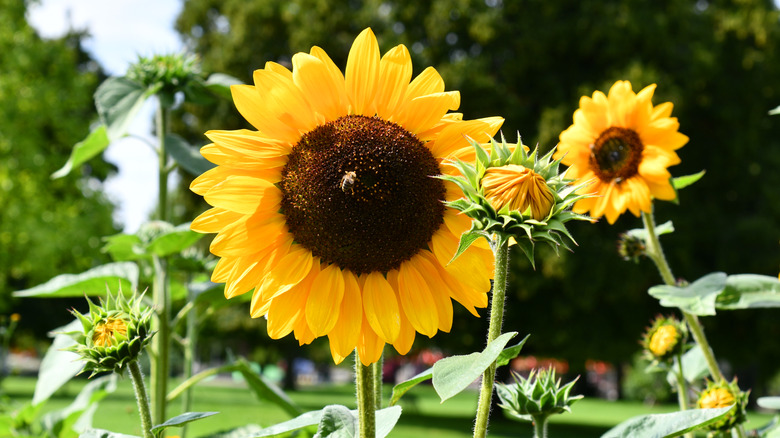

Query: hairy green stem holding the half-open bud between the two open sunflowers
[[474, 237, 509, 438]]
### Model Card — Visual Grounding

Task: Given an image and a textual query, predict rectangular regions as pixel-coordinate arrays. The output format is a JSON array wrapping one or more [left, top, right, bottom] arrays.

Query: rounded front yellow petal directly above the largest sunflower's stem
[[363, 272, 401, 344]]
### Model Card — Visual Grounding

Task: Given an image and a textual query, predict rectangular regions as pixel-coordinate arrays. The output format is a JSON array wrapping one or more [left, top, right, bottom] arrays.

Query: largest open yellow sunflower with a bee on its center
[[191, 29, 503, 365]]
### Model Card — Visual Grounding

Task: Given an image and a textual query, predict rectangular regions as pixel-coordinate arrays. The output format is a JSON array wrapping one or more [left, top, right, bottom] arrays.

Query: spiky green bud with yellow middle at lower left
[[68, 290, 153, 377]]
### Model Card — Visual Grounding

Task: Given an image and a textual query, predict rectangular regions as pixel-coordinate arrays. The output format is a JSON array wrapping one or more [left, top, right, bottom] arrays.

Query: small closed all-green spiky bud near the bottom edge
[[497, 368, 583, 422]]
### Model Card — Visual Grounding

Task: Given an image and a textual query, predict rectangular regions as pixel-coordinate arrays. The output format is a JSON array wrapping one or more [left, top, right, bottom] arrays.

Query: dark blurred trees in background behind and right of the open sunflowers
[[176, 0, 780, 386]]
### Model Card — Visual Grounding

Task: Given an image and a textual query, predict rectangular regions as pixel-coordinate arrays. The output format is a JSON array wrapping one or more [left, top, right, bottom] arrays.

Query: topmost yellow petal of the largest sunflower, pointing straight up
[[345, 28, 379, 116]]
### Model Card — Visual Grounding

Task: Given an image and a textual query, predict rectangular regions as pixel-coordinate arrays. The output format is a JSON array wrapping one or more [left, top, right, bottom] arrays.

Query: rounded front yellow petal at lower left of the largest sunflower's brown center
[[306, 264, 344, 337]]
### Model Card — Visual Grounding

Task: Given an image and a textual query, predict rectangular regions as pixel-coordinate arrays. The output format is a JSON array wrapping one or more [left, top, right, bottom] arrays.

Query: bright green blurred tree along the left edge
[[0, 0, 116, 335]]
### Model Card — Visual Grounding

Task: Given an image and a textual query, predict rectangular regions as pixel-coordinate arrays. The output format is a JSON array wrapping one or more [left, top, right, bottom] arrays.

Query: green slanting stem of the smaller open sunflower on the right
[[642, 212, 745, 438]]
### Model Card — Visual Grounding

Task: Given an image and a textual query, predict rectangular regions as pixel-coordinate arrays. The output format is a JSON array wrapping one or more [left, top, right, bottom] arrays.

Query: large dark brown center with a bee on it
[[280, 115, 445, 274]]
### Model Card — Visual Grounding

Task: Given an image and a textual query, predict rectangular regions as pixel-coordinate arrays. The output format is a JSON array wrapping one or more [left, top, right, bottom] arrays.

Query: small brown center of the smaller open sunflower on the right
[[590, 126, 644, 183]]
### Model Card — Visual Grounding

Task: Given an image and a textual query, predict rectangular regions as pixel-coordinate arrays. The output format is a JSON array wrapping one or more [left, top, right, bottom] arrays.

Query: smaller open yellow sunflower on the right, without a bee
[[555, 81, 688, 224]]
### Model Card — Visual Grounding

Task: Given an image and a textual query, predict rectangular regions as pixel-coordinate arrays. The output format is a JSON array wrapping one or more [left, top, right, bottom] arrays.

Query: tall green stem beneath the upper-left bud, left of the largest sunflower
[[151, 99, 171, 424]]
